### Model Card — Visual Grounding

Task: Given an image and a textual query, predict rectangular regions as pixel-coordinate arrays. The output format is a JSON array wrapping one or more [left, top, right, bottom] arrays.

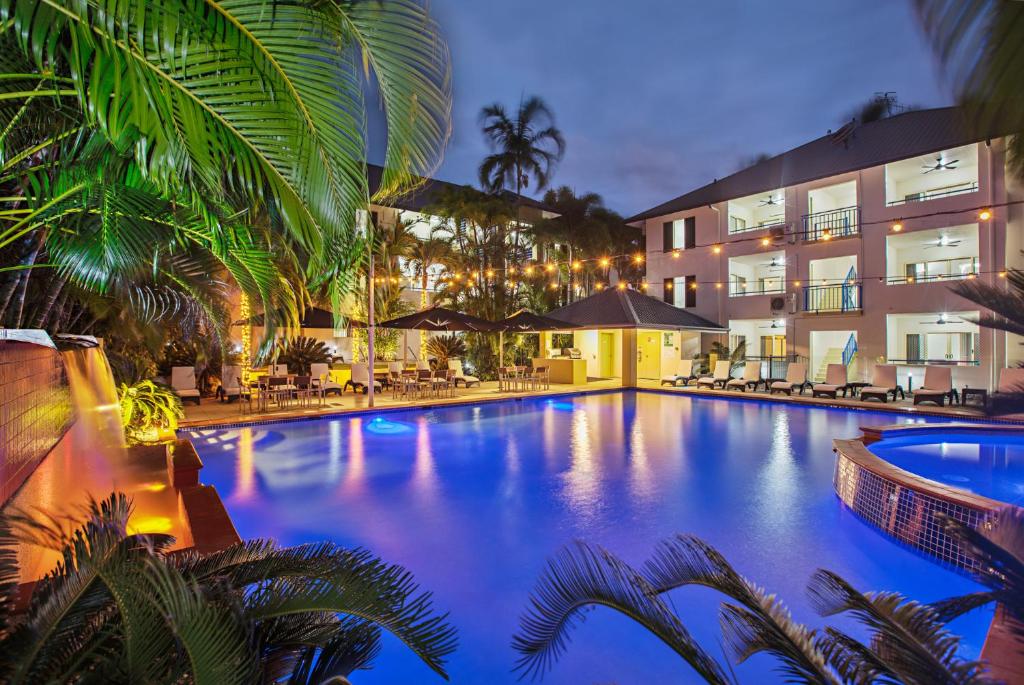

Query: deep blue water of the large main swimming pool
[[184, 392, 990, 683]]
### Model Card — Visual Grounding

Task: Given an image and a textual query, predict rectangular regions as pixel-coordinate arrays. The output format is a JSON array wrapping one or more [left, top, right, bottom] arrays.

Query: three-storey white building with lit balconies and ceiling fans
[[629, 108, 1024, 387]]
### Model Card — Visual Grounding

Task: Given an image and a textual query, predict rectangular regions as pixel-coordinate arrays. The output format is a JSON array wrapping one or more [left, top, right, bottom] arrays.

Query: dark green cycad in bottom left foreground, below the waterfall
[[0, 495, 456, 685]]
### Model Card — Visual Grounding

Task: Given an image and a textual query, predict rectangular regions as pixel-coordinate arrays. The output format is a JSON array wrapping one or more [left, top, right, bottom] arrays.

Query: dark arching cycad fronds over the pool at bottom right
[[520, 509, 1024, 685]]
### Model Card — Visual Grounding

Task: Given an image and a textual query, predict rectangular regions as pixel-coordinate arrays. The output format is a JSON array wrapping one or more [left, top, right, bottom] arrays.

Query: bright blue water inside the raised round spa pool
[[870, 431, 1024, 505]]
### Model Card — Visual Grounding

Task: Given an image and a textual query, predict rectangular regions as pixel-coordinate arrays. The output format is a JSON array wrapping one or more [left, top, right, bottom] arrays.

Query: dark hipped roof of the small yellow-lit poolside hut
[[545, 288, 728, 333]]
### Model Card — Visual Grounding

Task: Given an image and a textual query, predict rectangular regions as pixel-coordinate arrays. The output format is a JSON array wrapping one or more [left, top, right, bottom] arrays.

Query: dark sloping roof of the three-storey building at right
[[627, 108, 986, 222]]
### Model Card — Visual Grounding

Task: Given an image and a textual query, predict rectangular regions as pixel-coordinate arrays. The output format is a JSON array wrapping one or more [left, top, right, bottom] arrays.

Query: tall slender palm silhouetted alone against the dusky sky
[[479, 95, 565, 252]]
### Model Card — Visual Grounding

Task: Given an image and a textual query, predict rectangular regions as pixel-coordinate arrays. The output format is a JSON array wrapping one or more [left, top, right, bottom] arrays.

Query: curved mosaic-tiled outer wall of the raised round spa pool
[[834, 452, 991, 571]]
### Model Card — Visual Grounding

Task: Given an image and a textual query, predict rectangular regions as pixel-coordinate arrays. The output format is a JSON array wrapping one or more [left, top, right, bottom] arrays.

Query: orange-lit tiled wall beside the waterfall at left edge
[[0, 340, 73, 505]]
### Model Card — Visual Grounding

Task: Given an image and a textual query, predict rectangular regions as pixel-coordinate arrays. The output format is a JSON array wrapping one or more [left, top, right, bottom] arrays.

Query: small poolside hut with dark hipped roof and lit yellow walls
[[541, 287, 729, 386]]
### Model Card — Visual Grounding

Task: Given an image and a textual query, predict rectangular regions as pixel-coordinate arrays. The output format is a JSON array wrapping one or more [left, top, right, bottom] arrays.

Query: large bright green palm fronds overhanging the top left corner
[[0, 0, 451, 317]]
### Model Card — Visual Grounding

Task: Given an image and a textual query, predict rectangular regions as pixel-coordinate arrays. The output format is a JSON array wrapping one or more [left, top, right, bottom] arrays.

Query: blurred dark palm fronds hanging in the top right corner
[[914, 0, 1024, 178]]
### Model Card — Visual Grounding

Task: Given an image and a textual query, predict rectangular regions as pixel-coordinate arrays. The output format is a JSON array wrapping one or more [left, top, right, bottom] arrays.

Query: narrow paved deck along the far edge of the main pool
[[181, 379, 1024, 428]]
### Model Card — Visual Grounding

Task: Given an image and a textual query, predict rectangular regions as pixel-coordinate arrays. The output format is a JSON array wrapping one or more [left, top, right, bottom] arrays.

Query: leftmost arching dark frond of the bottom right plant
[[512, 542, 729, 683]]
